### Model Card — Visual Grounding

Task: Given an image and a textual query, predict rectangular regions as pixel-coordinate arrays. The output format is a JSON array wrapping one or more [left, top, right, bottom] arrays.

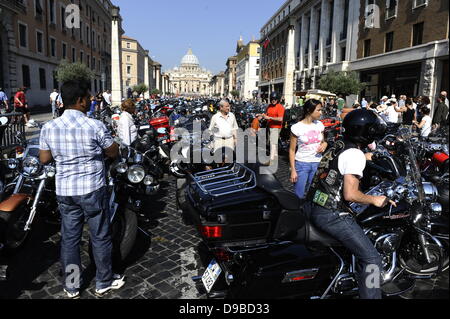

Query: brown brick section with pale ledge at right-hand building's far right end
[[350, 0, 449, 102]]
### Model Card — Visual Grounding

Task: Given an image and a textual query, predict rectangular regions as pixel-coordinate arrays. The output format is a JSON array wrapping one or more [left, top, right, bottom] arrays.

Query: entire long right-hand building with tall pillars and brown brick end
[[259, 0, 449, 105]]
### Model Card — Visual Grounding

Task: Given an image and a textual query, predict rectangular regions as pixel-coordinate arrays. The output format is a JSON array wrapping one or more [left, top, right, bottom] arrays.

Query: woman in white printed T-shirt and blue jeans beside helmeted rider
[[289, 100, 328, 199]]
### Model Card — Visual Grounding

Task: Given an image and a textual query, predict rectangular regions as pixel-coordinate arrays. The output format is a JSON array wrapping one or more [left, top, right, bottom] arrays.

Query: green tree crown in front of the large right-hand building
[[318, 71, 366, 96]]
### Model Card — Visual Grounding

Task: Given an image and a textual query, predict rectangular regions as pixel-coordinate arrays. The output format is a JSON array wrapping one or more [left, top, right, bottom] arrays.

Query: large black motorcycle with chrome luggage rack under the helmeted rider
[[180, 132, 448, 299]]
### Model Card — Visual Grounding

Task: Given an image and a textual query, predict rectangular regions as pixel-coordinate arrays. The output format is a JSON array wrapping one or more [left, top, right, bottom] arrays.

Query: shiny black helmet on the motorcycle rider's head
[[342, 109, 387, 146]]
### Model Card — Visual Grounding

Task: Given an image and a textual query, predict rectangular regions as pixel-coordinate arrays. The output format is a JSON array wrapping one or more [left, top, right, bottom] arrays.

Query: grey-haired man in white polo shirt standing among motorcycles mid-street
[[209, 100, 239, 151]]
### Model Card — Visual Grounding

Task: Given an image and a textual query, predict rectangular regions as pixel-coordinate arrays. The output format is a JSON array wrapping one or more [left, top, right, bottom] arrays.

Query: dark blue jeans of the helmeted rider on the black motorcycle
[[310, 205, 383, 299]]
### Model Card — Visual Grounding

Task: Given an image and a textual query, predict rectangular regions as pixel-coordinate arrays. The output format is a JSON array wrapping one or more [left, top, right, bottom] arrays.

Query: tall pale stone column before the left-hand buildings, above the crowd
[[111, 7, 123, 105]]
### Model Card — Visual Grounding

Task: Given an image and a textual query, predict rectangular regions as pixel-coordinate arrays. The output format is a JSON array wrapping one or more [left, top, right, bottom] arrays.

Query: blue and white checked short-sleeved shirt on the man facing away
[[40, 109, 114, 196]]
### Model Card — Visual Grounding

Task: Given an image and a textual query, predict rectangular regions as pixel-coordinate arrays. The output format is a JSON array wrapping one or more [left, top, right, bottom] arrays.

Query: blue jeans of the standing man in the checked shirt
[[58, 187, 113, 292]]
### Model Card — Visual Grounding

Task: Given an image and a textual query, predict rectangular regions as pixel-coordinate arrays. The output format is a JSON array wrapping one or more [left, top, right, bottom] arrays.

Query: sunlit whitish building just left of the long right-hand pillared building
[[236, 41, 261, 100]]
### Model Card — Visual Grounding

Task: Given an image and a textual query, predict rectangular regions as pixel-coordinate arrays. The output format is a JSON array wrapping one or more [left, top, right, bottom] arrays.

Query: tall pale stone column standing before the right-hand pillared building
[[283, 17, 298, 107]]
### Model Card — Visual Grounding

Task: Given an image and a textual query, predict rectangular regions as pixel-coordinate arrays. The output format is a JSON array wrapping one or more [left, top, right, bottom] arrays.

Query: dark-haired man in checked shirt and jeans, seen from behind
[[39, 80, 125, 299]]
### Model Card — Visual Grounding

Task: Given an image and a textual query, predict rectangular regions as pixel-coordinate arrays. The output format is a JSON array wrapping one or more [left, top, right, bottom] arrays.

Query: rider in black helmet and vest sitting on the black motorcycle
[[306, 109, 396, 299]]
